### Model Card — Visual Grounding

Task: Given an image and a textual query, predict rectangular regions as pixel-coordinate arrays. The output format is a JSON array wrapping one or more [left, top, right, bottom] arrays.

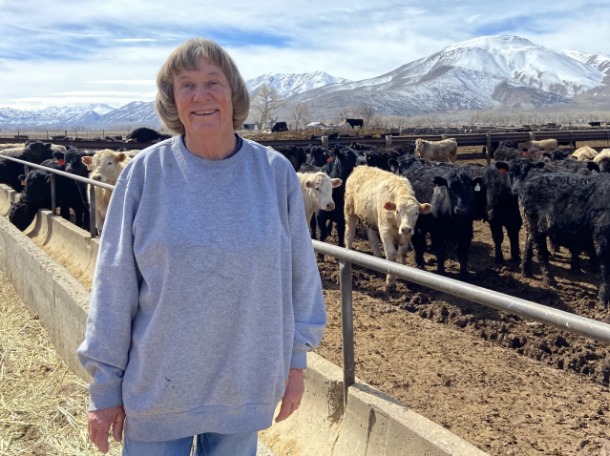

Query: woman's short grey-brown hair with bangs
[[155, 38, 250, 134]]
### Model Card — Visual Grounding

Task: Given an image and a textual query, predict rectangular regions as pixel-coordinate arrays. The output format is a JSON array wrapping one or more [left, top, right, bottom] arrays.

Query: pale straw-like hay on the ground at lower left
[[0, 272, 121, 456]]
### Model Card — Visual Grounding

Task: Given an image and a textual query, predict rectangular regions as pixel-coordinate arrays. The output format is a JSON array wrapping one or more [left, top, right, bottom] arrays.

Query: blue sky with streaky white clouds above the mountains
[[0, 0, 610, 109]]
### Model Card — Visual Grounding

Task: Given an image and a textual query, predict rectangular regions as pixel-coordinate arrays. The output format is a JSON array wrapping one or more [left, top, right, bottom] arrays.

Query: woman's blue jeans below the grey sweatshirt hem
[[123, 432, 258, 456]]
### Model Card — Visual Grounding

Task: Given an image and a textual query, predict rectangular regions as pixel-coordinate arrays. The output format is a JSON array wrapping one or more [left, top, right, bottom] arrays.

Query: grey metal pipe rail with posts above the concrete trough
[[3, 157, 610, 398]]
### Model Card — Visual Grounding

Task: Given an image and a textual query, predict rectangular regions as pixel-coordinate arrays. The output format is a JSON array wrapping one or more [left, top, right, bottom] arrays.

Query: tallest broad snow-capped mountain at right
[[280, 36, 605, 115]]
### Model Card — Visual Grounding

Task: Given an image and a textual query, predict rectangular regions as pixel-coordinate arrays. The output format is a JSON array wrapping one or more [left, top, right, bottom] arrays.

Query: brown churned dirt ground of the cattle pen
[[317, 222, 610, 455]]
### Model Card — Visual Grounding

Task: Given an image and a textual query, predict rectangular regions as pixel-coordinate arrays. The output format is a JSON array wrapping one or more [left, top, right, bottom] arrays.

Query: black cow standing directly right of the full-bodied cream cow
[[398, 155, 482, 281]]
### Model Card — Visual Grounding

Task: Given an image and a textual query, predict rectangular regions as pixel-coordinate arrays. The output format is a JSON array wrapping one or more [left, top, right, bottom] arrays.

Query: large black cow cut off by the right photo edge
[[509, 160, 610, 309]]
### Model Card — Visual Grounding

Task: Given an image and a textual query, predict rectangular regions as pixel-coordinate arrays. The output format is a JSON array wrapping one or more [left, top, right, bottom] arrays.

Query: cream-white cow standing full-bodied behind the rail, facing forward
[[345, 165, 432, 289]]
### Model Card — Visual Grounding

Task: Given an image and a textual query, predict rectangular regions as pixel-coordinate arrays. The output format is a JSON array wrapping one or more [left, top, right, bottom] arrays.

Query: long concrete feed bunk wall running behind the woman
[[0, 186, 486, 456]]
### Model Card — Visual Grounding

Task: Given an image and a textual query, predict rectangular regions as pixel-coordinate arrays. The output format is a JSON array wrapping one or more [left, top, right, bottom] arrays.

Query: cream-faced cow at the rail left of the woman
[[81, 149, 131, 234]]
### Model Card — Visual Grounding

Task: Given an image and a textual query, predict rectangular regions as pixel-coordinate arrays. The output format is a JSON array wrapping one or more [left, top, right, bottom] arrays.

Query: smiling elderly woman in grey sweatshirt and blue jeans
[[78, 38, 326, 456]]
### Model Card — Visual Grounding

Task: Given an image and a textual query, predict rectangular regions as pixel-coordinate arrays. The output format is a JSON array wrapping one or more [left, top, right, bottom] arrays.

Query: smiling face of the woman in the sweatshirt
[[173, 59, 233, 137]]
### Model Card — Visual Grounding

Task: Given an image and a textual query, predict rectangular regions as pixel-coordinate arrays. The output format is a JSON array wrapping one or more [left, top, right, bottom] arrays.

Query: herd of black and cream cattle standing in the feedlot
[[0, 134, 610, 309]]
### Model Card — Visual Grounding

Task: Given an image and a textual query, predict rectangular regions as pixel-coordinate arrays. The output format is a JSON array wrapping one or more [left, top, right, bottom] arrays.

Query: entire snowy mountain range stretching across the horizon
[[0, 35, 610, 130]]
